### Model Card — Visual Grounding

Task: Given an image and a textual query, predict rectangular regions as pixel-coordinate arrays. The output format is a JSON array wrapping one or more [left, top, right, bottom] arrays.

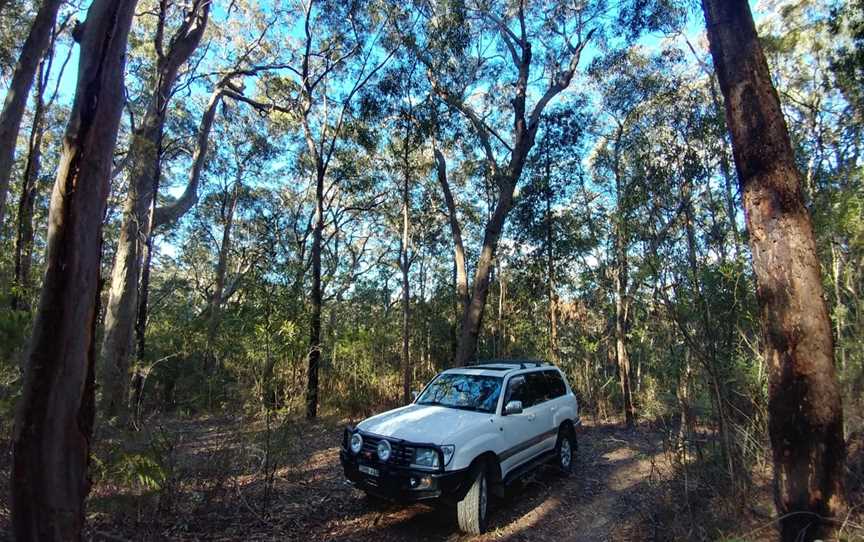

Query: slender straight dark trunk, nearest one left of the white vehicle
[[306, 166, 324, 420]]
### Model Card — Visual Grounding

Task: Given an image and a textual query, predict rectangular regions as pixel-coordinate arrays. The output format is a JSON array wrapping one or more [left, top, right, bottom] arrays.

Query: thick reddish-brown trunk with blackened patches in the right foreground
[[702, 0, 845, 540]]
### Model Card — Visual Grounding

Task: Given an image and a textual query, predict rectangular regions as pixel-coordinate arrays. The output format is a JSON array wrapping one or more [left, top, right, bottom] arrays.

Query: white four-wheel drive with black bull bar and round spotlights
[[339, 361, 579, 534]]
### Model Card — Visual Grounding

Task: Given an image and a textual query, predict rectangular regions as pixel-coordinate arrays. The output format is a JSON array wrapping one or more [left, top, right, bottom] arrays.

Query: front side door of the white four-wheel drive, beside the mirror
[[498, 373, 543, 476]]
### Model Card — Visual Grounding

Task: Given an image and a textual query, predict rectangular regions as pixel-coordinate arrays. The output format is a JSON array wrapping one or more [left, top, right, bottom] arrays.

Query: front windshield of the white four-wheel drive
[[417, 373, 502, 412]]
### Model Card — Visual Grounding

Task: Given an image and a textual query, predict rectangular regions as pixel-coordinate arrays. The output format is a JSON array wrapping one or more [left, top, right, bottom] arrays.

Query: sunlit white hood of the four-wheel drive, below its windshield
[[357, 404, 492, 445]]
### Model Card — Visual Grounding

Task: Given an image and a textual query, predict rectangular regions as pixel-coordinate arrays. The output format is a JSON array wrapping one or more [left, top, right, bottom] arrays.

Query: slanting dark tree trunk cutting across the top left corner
[[0, 0, 63, 225]]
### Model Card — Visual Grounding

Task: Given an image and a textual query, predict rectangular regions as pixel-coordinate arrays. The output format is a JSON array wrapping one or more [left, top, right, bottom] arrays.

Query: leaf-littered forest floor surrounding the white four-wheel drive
[[0, 418, 864, 542]]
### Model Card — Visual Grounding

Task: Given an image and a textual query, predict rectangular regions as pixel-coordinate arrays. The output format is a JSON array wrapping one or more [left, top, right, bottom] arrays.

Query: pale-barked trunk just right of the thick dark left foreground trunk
[[100, 0, 210, 423]]
